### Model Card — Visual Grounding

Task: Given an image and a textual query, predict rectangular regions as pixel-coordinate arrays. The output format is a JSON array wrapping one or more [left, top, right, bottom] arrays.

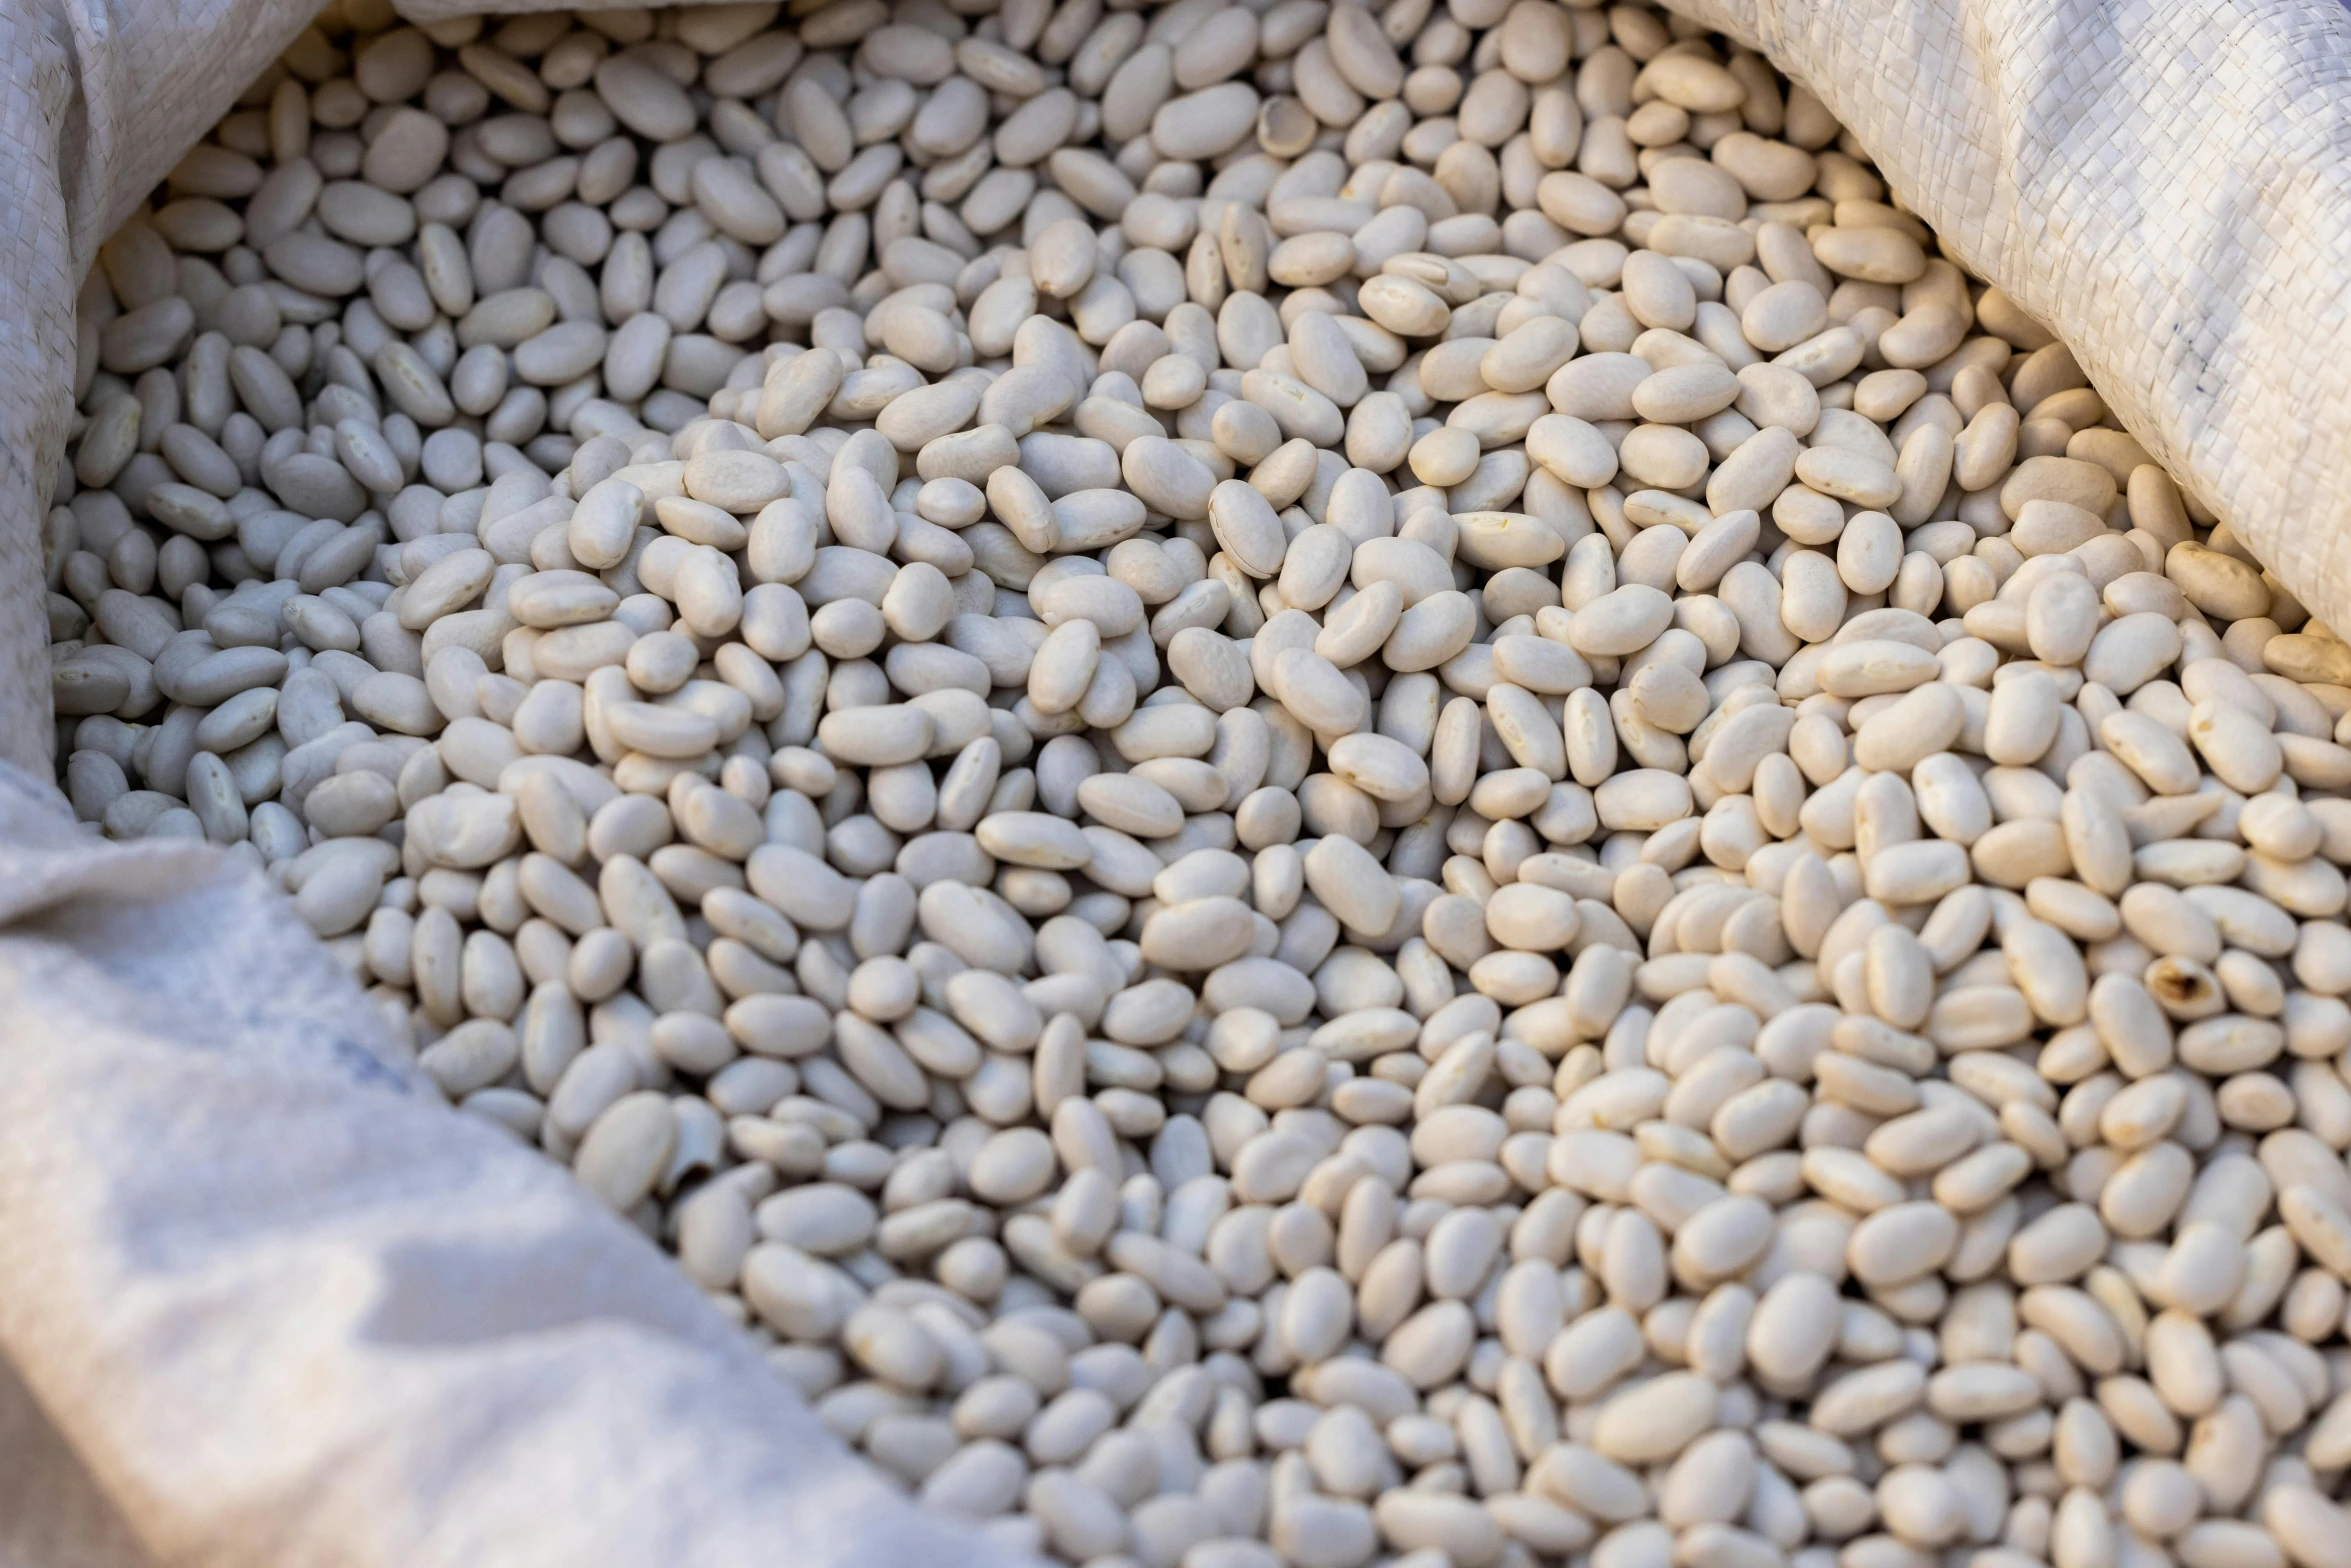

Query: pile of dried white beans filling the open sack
[[47, 0, 2351, 1568]]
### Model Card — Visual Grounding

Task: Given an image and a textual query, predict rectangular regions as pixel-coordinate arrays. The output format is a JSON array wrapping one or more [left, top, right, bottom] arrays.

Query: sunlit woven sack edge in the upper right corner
[[1660, 0, 2351, 630]]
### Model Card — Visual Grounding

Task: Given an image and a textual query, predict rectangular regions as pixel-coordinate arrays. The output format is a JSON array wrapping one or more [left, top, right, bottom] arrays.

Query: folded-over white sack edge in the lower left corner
[[0, 766, 1034, 1568]]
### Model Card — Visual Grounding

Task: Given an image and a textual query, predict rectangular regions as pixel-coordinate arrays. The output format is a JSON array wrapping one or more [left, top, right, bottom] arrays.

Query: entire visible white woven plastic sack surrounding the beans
[[0, 0, 2351, 1568]]
